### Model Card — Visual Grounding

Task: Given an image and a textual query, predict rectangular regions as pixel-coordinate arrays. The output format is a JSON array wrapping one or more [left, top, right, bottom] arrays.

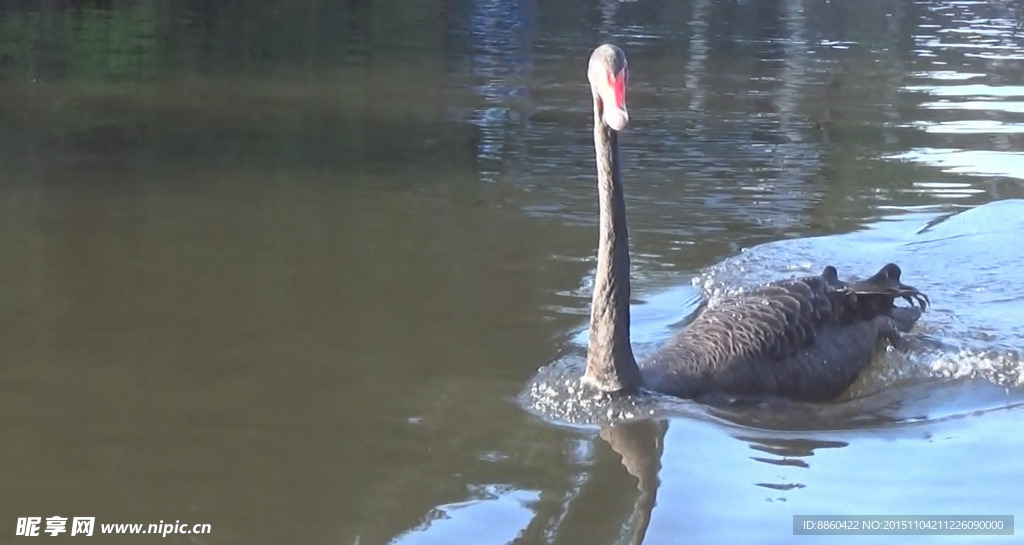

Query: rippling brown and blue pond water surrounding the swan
[[0, 0, 1024, 544]]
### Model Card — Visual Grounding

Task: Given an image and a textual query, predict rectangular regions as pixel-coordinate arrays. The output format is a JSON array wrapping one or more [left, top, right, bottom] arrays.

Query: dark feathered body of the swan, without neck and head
[[641, 263, 929, 401]]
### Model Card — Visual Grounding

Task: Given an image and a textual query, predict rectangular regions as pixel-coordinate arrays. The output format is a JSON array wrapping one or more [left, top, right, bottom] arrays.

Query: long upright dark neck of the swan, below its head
[[584, 103, 640, 391]]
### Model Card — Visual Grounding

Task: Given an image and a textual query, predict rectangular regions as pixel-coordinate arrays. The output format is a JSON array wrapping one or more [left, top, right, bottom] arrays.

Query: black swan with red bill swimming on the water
[[583, 44, 929, 402]]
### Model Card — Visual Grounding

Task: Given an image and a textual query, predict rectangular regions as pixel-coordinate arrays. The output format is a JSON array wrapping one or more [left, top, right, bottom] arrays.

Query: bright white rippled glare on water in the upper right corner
[[889, 2, 1024, 189]]
